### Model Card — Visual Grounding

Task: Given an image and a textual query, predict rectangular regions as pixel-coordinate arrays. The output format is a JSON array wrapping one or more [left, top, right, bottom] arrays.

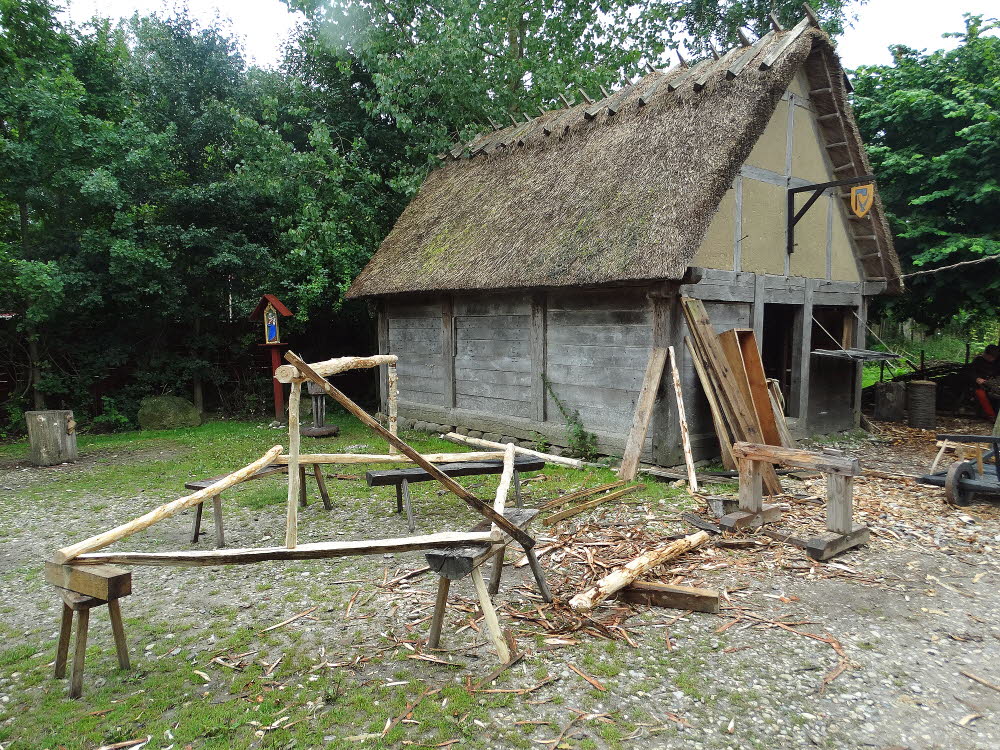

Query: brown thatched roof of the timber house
[[348, 21, 899, 297]]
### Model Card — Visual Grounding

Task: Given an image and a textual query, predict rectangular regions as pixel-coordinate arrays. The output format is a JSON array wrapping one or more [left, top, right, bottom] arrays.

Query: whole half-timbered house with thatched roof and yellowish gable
[[349, 18, 901, 465]]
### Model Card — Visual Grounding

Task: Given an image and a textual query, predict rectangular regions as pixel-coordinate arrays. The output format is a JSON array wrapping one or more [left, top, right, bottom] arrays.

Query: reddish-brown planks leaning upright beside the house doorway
[[681, 297, 794, 495]]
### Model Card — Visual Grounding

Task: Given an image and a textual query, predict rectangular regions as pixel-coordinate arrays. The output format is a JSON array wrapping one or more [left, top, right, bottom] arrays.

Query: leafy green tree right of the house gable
[[854, 15, 1000, 325]]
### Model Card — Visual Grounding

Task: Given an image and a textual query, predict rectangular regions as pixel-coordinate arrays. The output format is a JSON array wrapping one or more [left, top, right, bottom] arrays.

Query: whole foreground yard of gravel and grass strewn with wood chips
[[0, 428, 1000, 749]]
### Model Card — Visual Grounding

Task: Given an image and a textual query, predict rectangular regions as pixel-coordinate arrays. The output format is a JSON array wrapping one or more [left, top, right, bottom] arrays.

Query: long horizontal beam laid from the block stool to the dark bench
[[71, 531, 492, 566]]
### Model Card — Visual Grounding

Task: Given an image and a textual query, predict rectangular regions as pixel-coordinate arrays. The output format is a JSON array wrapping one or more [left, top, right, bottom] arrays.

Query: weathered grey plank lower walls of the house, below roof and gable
[[377, 268, 885, 465]]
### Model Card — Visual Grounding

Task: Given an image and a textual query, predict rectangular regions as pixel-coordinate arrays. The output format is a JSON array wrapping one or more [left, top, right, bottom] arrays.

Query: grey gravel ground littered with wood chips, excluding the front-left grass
[[0, 428, 1000, 748]]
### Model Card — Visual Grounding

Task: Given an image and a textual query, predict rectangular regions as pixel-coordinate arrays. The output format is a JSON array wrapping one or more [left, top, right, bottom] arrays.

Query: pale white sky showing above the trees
[[63, 0, 1000, 68]]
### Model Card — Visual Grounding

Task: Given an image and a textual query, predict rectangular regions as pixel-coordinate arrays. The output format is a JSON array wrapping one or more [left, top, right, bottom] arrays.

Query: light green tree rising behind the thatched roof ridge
[[285, 0, 860, 192]]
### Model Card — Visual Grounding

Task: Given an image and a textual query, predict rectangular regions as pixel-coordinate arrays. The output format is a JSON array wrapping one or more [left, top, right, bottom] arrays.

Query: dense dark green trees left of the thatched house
[[0, 0, 402, 427]]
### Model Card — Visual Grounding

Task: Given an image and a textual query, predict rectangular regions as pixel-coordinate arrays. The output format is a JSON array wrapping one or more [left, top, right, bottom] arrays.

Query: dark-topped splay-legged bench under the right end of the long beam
[[426, 508, 552, 663]]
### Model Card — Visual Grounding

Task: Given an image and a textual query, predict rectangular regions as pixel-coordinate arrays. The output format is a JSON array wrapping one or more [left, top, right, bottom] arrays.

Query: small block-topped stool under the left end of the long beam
[[45, 562, 132, 698]]
